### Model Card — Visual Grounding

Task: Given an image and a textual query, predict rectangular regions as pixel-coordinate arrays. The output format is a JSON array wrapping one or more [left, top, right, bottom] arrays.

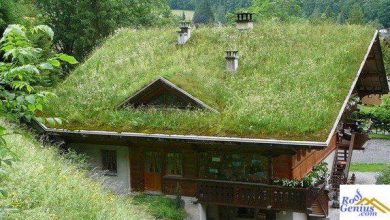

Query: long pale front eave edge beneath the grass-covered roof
[[34, 121, 328, 149]]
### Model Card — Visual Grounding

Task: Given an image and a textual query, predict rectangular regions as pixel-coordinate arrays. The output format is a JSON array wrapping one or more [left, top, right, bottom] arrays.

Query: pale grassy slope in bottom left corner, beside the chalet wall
[[0, 119, 185, 220]]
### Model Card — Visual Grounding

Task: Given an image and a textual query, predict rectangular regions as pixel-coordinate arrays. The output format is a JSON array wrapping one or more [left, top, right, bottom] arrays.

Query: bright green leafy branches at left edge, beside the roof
[[0, 25, 77, 121]]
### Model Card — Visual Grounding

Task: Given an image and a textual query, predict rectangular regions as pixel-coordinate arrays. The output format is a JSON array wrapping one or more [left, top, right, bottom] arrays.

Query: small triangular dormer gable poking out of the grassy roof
[[119, 77, 217, 112]]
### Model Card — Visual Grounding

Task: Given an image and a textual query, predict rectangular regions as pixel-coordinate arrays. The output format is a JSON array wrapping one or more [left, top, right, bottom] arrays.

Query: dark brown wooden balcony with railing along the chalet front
[[163, 177, 327, 214]]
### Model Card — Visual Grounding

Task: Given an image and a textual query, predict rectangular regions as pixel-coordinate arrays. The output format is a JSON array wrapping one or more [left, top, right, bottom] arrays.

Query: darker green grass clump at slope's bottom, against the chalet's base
[[133, 194, 186, 220]]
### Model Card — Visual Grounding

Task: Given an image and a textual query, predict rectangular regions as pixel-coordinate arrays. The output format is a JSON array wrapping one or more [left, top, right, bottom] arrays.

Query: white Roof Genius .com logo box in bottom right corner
[[340, 185, 390, 220]]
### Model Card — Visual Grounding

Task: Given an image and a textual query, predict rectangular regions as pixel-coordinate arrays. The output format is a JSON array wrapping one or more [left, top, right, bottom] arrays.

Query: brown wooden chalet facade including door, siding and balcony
[[129, 139, 335, 213]]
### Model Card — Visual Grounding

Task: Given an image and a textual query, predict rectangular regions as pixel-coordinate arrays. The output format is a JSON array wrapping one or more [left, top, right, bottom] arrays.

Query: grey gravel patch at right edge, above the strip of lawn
[[352, 139, 390, 164]]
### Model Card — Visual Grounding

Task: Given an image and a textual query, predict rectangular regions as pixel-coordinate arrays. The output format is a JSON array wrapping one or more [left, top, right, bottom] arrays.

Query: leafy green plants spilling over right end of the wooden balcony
[[274, 162, 328, 188]]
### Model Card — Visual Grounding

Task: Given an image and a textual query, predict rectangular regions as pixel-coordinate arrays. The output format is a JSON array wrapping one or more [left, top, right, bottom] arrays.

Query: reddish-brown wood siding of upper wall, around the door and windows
[[130, 139, 335, 196]]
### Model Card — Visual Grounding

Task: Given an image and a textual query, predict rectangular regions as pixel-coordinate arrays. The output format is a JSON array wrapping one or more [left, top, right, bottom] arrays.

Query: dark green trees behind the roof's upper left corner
[[37, 0, 174, 59]]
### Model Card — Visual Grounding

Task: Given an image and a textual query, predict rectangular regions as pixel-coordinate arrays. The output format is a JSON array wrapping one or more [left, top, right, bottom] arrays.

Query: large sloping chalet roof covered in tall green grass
[[45, 22, 374, 141]]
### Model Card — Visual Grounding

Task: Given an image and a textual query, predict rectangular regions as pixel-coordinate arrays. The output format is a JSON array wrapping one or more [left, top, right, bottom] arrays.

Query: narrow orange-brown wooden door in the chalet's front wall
[[144, 151, 162, 191]]
